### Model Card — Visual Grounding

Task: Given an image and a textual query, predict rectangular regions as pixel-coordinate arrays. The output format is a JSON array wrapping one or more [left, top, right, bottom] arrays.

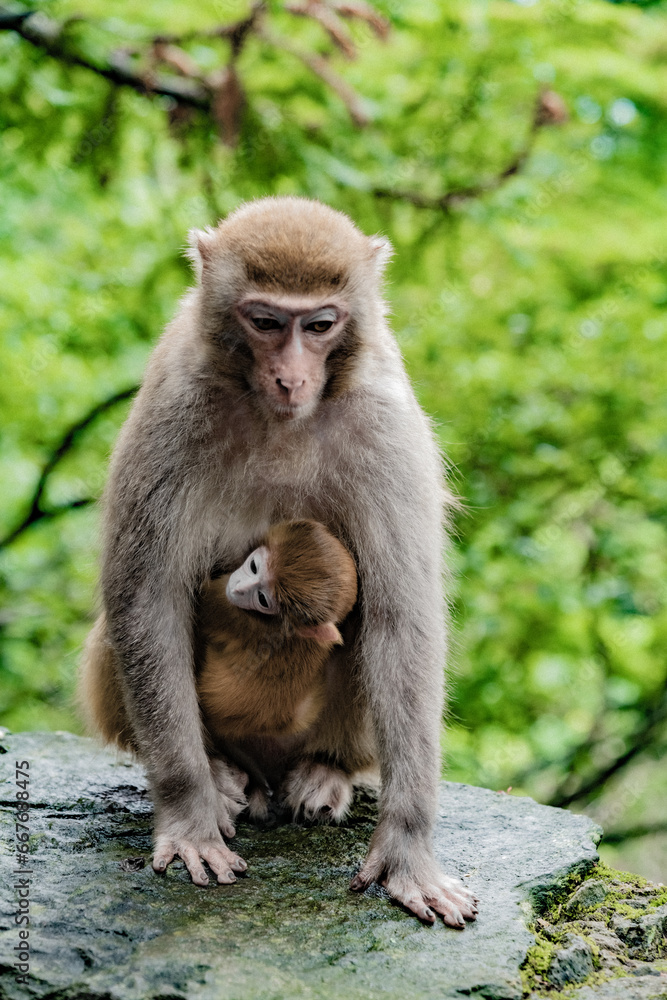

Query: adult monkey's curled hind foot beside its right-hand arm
[[284, 760, 352, 823]]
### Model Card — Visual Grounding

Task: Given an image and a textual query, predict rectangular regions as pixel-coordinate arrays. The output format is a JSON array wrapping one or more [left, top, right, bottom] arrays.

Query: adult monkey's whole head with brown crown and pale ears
[[189, 198, 390, 421]]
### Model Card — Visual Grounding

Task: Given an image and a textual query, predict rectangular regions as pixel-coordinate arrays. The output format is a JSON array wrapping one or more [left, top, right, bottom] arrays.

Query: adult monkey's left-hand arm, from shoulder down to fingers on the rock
[[102, 395, 246, 885]]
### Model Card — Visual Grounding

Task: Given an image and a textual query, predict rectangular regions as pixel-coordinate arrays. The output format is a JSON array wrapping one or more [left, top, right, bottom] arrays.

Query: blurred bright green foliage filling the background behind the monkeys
[[0, 0, 667, 868]]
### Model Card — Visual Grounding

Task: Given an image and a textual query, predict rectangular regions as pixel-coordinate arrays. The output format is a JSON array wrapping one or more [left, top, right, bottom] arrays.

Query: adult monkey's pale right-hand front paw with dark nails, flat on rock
[[350, 850, 478, 930]]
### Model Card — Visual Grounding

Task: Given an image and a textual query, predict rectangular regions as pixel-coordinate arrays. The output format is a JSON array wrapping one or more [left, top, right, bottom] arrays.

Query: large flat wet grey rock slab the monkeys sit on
[[0, 733, 604, 1000]]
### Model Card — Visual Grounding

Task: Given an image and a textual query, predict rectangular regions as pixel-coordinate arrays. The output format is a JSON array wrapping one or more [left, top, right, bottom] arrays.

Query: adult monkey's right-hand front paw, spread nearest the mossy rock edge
[[350, 829, 478, 929]]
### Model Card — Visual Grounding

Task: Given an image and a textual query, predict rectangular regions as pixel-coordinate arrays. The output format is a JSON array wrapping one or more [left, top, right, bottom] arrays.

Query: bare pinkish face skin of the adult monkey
[[236, 293, 349, 420]]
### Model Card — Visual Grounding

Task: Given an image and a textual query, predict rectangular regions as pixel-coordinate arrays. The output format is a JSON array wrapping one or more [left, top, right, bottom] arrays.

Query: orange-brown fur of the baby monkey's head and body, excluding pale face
[[197, 520, 357, 746]]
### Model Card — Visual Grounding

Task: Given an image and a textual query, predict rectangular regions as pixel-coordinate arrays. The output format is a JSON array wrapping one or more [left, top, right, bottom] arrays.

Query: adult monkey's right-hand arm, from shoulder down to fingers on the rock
[[348, 394, 477, 927]]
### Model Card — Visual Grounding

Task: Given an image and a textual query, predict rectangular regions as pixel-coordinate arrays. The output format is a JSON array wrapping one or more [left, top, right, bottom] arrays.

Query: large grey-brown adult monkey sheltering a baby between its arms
[[96, 198, 477, 927]]
